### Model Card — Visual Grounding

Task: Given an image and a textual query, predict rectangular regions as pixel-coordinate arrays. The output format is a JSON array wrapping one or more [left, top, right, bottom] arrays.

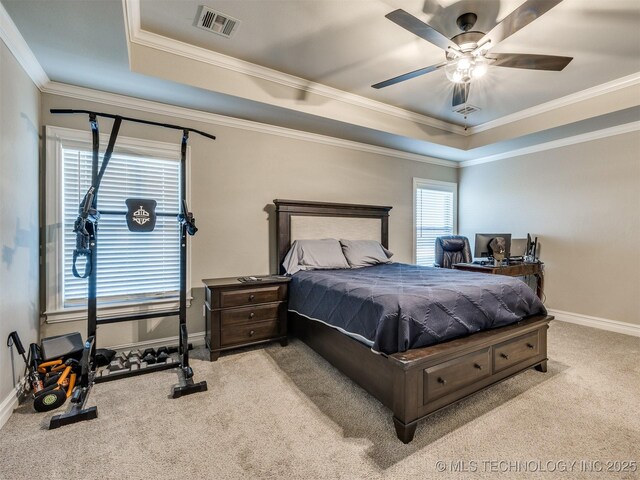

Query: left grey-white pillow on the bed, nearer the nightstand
[[282, 238, 350, 275]]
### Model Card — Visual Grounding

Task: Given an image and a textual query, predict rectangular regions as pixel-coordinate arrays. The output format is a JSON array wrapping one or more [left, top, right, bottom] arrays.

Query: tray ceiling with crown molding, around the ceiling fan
[[0, 0, 640, 162]]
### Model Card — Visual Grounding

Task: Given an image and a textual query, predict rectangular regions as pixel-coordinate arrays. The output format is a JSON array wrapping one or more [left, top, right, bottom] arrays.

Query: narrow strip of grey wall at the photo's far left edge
[[0, 41, 40, 402]]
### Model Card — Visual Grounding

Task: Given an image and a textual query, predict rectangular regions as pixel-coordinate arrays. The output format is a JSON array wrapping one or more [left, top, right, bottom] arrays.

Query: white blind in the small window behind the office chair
[[415, 185, 454, 266]]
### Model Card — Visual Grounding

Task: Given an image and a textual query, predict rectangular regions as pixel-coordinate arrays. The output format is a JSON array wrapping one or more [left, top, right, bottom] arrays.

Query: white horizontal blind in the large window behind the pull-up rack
[[62, 146, 180, 307]]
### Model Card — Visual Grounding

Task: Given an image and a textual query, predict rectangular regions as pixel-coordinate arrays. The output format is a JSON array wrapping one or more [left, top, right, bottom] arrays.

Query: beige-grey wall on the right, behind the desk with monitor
[[458, 132, 640, 324]]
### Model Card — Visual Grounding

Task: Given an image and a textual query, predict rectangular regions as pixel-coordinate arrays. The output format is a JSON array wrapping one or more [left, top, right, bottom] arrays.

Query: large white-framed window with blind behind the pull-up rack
[[46, 127, 188, 321]]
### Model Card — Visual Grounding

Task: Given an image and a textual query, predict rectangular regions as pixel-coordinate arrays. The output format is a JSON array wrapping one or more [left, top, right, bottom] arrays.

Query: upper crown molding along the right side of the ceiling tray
[[469, 72, 640, 135]]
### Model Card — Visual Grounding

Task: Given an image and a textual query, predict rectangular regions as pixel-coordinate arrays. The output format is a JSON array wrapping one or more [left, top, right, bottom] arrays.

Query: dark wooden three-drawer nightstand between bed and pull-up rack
[[203, 277, 291, 362]]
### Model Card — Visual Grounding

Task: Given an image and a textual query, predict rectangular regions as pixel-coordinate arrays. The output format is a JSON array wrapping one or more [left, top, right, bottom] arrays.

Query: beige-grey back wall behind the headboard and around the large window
[[42, 94, 457, 345]]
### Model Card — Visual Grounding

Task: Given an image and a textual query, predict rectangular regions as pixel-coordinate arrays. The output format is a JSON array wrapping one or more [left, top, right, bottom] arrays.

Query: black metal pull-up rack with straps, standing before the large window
[[45, 109, 215, 428]]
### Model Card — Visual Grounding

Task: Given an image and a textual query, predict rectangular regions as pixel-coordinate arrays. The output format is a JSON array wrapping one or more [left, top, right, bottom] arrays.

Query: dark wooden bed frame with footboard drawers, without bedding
[[274, 200, 553, 443]]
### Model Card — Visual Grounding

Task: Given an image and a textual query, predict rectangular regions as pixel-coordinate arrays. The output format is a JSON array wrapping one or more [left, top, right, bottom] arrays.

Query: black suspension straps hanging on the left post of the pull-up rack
[[71, 114, 122, 278]]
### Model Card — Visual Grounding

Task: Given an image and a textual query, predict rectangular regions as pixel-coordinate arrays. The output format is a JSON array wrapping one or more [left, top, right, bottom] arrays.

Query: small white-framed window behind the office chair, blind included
[[413, 178, 458, 266]]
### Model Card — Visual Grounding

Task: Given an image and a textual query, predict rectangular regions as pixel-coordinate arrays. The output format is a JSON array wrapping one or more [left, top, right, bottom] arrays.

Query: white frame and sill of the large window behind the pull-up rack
[[42, 125, 192, 323]]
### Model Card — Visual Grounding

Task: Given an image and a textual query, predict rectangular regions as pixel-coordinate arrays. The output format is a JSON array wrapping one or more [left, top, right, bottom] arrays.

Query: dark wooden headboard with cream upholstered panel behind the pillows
[[273, 199, 393, 273]]
